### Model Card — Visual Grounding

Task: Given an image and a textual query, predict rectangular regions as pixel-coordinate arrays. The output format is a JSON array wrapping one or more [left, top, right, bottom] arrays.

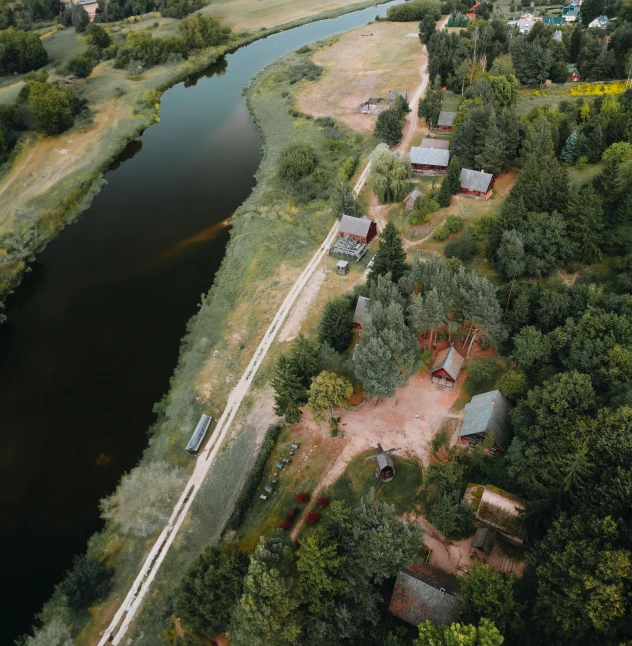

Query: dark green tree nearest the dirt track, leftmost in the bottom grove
[[175, 547, 248, 635]]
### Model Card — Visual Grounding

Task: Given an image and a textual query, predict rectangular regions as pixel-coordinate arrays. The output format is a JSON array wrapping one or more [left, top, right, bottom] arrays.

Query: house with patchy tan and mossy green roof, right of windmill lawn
[[463, 484, 527, 546]]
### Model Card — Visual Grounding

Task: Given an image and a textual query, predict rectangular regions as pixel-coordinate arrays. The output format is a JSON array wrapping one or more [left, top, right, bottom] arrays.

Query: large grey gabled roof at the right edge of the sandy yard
[[459, 390, 512, 451]]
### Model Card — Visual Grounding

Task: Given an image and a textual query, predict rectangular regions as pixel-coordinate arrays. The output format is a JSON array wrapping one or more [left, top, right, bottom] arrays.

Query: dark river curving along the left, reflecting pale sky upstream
[[0, 2, 395, 646]]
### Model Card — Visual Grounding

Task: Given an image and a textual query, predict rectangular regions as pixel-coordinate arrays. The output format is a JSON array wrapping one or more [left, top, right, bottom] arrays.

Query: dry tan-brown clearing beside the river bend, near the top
[[297, 22, 424, 131]]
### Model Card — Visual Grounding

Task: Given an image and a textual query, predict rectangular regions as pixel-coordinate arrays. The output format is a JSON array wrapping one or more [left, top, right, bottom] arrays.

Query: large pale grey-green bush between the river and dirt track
[[99, 462, 186, 538]]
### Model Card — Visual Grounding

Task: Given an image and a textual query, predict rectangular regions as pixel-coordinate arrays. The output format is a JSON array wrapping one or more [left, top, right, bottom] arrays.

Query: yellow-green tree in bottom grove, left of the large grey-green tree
[[296, 534, 345, 615]]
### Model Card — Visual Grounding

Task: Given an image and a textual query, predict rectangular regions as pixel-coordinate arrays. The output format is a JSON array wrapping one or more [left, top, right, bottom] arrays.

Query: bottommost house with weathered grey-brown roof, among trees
[[388, 563, 461, 626]]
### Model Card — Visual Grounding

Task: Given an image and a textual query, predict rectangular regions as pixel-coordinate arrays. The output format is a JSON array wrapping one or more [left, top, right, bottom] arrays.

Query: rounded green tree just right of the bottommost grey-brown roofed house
[[460, 565, 518, 633]]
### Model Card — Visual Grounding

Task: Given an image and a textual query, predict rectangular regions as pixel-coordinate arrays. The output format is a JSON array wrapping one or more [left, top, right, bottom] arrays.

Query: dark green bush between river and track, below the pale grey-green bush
[[58, 554, 113, 613]]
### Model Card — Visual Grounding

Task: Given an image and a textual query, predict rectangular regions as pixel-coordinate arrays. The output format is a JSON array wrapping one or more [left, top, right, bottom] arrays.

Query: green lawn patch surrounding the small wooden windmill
[[327, 447, 423, 516]]
